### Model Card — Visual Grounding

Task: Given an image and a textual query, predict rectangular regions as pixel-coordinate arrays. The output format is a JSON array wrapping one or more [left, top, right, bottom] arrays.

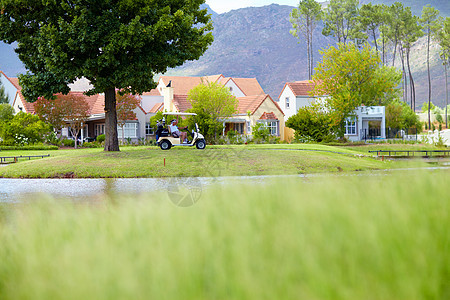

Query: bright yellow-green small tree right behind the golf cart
[[188, 82, 238, 141]]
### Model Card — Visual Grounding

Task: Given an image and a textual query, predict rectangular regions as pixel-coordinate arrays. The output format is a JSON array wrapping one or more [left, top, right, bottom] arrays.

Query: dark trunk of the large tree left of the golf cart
[[104, 88, 120, 151]]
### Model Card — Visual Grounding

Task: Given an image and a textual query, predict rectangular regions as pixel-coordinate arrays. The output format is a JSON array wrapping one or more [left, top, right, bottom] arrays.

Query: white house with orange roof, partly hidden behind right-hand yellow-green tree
[[278, 80, 386, 141]]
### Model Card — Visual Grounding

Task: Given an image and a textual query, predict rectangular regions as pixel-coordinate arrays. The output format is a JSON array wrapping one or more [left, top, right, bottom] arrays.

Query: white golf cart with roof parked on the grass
[[156, 112, 206, 150]]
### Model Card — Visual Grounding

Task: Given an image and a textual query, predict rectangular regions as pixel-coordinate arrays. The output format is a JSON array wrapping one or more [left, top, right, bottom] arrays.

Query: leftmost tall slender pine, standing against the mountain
[[290, 0, 322, 80]]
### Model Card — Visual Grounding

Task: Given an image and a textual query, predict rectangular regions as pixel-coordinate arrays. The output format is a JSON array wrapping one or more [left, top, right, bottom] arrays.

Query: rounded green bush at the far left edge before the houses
[[0, 112, 51, 146]]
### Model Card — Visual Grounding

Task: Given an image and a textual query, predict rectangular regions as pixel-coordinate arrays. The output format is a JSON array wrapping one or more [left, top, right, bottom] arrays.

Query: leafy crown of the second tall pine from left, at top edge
[[322, 0, 363, 44]]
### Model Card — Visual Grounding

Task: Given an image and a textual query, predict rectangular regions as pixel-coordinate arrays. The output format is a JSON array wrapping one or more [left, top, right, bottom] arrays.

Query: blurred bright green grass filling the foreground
[[0, 170, 450, 300]]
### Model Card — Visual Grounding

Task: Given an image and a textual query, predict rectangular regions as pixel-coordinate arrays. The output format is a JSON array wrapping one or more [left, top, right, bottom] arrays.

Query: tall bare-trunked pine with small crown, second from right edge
[[420, 4, 439, 128]]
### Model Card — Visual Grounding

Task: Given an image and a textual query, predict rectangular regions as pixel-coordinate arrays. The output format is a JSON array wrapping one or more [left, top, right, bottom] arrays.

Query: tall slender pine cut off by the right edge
[[436, 17, 450, 128]]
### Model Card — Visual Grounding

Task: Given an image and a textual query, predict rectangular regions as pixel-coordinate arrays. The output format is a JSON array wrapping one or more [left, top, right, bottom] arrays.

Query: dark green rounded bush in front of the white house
[[286, 107, 335, 142]]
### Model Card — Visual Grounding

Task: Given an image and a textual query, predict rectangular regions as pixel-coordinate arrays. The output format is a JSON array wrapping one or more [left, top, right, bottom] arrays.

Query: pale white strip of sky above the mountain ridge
[[206, 0, 325, 14]]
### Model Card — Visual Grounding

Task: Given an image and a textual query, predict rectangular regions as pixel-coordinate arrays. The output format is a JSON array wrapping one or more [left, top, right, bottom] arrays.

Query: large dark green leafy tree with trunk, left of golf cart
[[0, 0, 213, 151]]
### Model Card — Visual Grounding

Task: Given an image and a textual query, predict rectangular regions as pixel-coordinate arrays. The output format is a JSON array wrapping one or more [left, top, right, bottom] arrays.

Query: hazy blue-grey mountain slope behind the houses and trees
[[0, 0, 450, 107]]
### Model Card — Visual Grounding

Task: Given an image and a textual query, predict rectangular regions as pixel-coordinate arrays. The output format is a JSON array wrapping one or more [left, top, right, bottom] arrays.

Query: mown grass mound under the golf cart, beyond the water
[[0, 144, 428, 178]]
